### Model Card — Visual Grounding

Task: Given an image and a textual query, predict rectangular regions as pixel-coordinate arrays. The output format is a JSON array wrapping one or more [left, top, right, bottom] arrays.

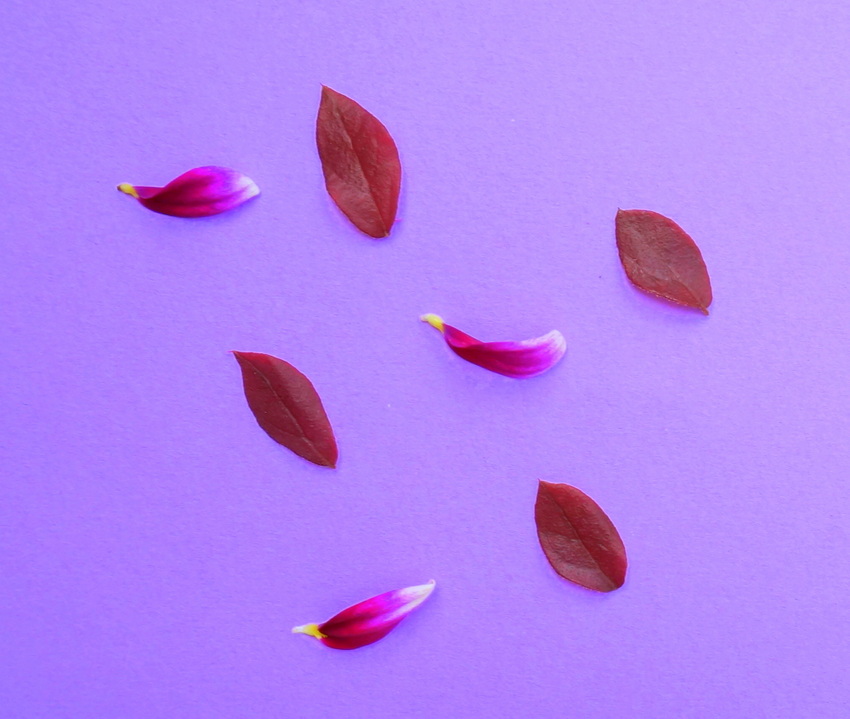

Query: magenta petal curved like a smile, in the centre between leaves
[[421, 314, 567, 379]]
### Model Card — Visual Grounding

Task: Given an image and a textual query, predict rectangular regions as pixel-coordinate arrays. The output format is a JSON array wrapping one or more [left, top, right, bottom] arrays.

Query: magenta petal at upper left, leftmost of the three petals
[[118, 166, 260, 217]]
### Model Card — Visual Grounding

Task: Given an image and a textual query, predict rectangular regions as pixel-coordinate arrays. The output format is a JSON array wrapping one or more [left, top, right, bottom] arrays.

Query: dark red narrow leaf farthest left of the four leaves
[[233, 352, 338, 467]]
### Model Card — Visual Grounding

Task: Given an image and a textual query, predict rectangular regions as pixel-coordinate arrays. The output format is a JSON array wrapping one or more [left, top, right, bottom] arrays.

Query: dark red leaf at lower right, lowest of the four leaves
[[534, 481, 626, 592]]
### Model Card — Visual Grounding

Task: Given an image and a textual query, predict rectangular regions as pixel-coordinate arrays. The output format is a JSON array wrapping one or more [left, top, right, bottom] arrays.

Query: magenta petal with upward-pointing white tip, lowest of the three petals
[[292, 579, 436, 649]]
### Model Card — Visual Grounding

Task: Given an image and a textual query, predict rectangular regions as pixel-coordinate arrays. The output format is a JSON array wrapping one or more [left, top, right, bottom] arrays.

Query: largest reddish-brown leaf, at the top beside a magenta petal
[[316, 85, 401, 237]]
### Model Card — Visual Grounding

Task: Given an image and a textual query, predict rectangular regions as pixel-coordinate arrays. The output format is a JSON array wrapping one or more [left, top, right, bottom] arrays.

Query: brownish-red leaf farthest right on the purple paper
[[617, 210, 711, 314]]
